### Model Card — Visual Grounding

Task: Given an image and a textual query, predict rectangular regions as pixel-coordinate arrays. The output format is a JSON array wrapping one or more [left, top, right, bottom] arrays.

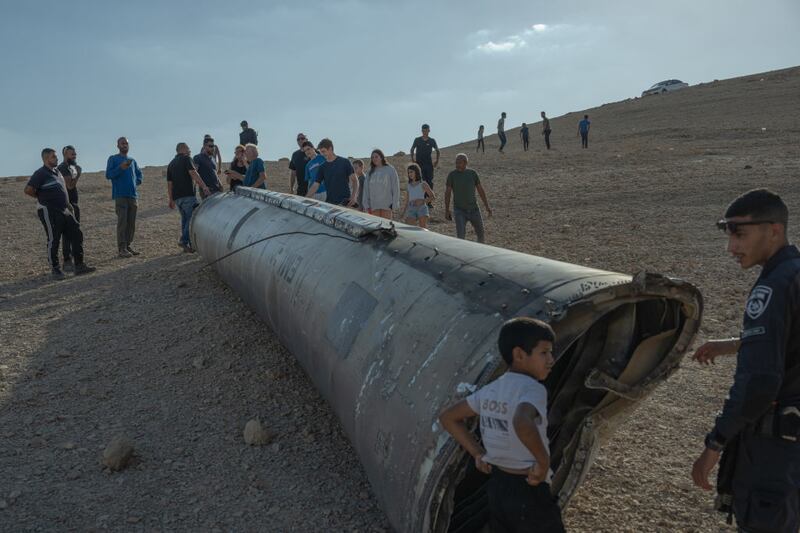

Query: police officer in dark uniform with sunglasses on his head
[[692, 189, 800, 532]]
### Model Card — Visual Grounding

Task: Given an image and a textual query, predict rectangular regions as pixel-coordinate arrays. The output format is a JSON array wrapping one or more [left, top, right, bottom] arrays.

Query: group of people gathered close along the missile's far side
[[167, 121, 492, 252]]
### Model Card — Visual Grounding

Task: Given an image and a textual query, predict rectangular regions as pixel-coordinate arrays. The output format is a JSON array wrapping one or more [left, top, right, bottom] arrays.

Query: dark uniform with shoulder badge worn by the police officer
[[709, 246, 800, 532]]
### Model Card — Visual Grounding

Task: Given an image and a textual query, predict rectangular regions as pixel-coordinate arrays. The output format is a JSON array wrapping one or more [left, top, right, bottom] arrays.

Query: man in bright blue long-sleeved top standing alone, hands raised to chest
[[106, 137, 142, 257]]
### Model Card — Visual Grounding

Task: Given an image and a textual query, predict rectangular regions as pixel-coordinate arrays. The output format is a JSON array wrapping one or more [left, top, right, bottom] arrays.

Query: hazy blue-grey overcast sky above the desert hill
[[0, 0, 800, 176]]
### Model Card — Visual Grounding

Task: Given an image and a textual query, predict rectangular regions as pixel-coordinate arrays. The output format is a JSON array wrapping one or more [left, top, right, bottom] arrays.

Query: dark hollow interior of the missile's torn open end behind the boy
[[440, 298, 685, 533]]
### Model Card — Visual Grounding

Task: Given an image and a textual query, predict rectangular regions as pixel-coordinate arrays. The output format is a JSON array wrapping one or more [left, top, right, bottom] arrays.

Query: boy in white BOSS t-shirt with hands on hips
[[439, 317, 564, 533]]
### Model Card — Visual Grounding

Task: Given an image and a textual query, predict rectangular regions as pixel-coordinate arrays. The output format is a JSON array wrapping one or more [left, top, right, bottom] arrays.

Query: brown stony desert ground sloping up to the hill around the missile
[[0, 64, 800, 531]]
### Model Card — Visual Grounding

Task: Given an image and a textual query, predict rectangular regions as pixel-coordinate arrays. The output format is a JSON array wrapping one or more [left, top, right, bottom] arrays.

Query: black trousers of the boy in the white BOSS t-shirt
[[486, 467, 564, 533]]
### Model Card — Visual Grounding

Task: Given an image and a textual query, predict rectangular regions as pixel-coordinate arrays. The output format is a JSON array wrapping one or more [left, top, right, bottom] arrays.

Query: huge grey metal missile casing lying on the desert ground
[[191, 187, 703, 532]]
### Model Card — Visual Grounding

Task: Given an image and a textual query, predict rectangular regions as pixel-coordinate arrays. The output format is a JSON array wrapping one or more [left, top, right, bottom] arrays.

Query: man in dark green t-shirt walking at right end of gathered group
[[444, 154, 492, 242]]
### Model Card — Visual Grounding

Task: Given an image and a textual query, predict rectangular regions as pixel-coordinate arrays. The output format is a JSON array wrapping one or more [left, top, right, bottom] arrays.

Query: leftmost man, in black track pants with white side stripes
[[25, 148, 96, 279]]
